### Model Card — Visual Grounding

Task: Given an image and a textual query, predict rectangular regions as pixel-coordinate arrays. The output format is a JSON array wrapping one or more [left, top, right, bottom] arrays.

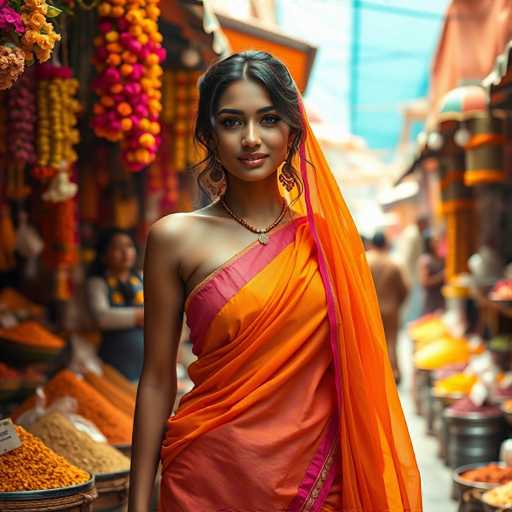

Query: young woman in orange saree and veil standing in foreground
[[129, 51, 421, 512]]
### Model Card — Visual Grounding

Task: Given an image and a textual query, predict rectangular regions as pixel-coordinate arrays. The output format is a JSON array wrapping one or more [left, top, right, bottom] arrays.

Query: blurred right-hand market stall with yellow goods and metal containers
[[404, 39, 512, 512]]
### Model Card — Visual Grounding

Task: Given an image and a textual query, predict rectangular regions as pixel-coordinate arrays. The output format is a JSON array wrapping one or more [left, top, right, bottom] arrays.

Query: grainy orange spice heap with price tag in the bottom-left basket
[[0, 426, 91, 492]]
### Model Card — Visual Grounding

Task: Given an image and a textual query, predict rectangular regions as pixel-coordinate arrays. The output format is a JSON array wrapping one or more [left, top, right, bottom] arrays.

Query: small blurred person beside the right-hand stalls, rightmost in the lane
[[418, 230, 444, 315]]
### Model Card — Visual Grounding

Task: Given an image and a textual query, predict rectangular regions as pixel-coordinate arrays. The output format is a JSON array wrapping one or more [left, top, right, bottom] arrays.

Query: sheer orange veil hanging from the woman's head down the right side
[[294, 96, 422, 512]]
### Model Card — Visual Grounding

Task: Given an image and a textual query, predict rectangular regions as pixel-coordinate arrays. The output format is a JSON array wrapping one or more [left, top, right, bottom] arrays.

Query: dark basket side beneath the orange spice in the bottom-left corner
[[0, 477, 98, 512]]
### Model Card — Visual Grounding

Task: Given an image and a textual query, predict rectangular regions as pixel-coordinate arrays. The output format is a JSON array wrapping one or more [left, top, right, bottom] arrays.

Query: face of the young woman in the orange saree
[[214, 80, 290, 181]]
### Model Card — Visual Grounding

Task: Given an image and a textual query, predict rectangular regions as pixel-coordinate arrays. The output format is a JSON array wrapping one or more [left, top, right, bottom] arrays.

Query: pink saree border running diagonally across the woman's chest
[[185, 217, 306, 355]]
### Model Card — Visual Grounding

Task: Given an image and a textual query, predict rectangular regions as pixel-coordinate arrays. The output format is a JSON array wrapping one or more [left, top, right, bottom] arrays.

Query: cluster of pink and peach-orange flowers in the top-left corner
[[0, 0, 61, 89]]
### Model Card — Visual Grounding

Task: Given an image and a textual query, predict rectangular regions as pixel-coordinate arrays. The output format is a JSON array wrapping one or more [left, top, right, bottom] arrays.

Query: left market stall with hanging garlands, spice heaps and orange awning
[[0, 0, 315, 504]]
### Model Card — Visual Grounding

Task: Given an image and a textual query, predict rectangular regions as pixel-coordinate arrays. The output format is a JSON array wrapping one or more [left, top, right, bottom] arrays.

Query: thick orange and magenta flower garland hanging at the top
[[92, 0, 166, 171]]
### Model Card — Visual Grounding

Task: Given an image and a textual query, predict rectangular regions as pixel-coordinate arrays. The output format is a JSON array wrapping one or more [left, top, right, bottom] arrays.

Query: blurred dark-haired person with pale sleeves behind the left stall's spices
[[87, 228, 144, 381]]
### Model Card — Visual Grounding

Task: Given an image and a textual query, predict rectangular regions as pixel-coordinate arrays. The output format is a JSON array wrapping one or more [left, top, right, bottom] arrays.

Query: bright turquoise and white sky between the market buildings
[[277, 0, 448, 152]]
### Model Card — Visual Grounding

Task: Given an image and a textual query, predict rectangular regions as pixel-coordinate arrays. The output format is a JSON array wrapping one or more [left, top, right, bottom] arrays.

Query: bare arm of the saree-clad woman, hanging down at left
[[128, 217, 183, 512]]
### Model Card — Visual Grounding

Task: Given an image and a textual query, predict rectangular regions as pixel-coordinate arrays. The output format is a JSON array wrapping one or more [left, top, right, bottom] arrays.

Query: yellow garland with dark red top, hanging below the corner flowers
[[33, 64, 81, 181]]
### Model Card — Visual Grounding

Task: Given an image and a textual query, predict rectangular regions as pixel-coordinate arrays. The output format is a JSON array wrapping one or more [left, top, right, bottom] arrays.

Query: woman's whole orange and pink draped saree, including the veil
[[160, 98, 422, 512]]
